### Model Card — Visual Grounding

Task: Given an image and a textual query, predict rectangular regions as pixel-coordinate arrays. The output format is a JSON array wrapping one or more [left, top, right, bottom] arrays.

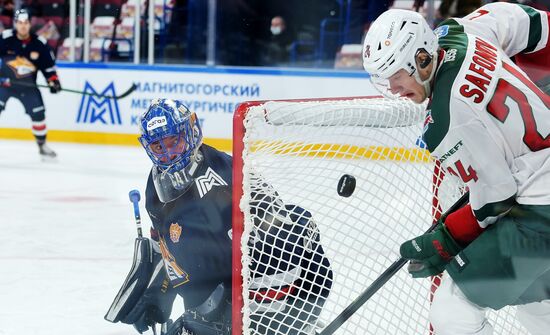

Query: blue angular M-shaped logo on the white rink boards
[[76, 81, 122, 125]]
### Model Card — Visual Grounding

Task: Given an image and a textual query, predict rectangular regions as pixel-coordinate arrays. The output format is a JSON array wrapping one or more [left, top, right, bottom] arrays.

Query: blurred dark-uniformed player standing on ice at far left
[[0, 9, 61, 158]]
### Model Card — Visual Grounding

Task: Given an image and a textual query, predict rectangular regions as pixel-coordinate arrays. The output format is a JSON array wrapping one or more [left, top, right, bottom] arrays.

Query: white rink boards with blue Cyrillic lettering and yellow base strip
[[0, 63, 376, 151]]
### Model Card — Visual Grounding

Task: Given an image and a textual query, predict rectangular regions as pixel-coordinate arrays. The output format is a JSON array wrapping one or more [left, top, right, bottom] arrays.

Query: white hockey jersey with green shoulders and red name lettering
[[423, 3, 550, 227]]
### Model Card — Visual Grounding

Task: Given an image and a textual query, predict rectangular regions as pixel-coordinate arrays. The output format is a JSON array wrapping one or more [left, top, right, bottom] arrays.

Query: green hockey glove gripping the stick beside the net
[[399, 222, 462, 278]]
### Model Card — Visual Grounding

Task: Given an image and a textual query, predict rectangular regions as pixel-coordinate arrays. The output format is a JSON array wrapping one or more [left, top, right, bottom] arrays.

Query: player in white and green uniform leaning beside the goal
[[363, 3, 550, 335]]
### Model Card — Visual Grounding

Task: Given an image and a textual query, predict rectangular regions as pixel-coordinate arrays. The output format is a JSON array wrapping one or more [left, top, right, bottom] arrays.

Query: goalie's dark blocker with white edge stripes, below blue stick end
[[105, 237, 176, 333]]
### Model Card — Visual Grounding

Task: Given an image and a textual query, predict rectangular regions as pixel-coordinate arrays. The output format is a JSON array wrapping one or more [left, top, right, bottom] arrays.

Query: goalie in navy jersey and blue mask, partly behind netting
[[105, 99, 332, 335]]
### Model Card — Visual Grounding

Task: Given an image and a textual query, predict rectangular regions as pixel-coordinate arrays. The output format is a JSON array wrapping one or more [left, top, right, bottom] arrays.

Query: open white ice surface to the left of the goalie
[[0, 140, 168, 335]]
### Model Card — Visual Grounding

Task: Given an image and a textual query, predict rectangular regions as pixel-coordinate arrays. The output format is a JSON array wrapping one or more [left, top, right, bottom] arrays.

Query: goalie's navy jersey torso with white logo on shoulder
[[146, 144, 232, 307]]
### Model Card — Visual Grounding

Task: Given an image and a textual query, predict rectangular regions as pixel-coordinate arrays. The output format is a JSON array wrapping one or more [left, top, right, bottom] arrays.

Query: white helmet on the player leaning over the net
[[363, 9, 438, 98]]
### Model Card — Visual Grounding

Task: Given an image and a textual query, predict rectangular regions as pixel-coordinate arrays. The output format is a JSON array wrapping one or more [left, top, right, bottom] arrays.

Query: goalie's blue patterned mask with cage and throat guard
[[139, 99, 202, 203]]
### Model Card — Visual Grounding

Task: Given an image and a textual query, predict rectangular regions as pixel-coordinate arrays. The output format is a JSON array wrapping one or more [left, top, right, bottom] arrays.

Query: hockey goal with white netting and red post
[[232, 97, 527, 335]]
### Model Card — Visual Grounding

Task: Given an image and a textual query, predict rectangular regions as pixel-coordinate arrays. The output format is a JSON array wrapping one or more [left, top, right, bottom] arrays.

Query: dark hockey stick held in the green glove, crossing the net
[[318, 192, 469, 335]]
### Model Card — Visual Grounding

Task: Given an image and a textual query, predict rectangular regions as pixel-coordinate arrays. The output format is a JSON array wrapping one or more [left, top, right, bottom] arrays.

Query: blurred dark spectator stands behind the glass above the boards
[[0, 0, 550, 68]]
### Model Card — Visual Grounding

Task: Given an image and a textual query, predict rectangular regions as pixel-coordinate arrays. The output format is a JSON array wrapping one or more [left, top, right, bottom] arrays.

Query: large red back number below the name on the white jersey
[[487, 63, 550, 151]]
